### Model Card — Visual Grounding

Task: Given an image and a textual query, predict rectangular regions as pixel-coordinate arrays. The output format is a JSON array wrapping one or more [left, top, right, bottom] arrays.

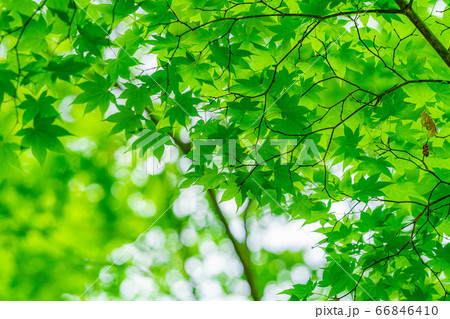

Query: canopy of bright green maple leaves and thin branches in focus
[[0, 0, 450, 300]]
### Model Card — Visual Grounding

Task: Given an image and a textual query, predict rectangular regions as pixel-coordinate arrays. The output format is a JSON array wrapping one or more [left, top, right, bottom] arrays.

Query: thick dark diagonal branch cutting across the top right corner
[[395, 0, 450, 68]]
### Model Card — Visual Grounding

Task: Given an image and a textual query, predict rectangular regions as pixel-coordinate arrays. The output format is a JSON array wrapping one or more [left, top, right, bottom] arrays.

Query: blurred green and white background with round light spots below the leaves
[[0, 107, 322, 300]]
